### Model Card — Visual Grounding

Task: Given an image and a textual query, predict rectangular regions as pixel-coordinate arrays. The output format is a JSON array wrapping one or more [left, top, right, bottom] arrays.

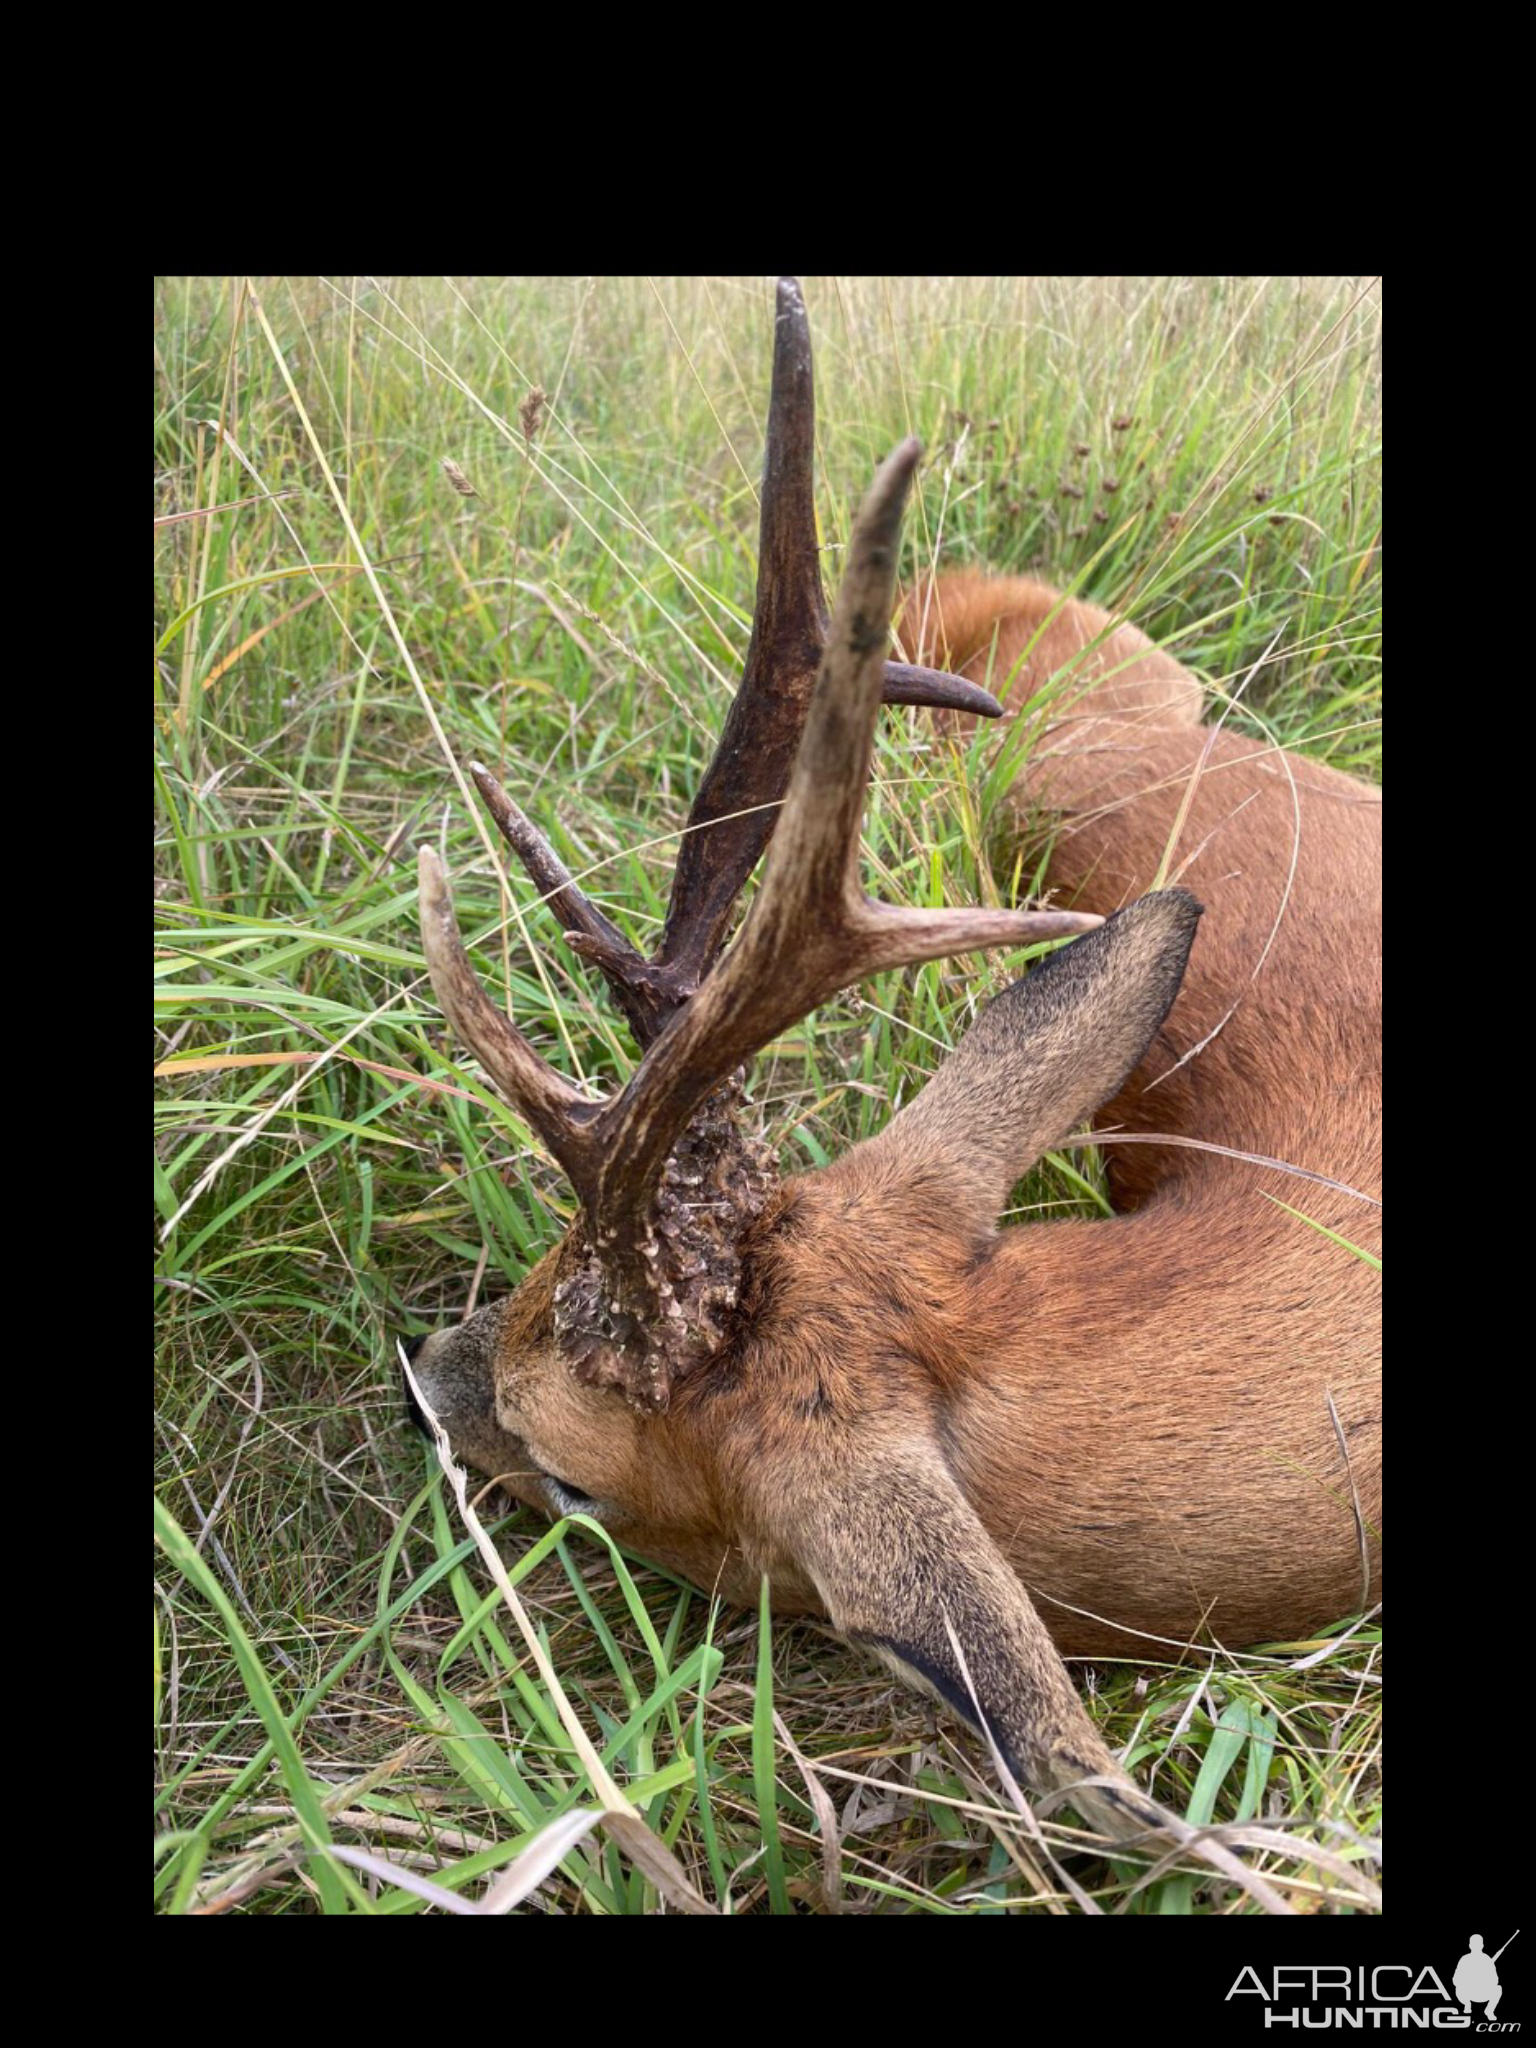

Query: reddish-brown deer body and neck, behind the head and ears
[[884, 575, 1382, 1653]]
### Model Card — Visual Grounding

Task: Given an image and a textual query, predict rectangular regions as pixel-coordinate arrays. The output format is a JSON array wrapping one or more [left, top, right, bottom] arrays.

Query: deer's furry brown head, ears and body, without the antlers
[[409, 575, 1380, 1831]]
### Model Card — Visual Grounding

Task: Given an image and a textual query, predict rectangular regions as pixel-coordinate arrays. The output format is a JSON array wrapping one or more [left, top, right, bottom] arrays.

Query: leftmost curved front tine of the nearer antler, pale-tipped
[[428, 846, 602, 1212]]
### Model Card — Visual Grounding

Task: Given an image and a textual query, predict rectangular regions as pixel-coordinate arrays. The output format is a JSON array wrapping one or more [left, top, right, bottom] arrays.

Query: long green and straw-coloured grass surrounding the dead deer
[[154, 279, 1380, 1915]]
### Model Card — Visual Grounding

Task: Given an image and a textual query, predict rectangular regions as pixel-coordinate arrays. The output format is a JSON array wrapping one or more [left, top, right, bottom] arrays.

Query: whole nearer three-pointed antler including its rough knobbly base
[[420, 440, 1102, 1407]]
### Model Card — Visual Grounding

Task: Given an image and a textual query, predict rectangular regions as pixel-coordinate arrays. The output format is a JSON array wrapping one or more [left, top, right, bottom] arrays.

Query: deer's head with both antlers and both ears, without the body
[[414, 281, 1198, 1867]]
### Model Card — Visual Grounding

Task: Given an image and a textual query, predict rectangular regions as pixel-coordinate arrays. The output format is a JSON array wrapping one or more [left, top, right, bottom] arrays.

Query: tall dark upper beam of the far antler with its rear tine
[[645, 276, 1001, 1010]]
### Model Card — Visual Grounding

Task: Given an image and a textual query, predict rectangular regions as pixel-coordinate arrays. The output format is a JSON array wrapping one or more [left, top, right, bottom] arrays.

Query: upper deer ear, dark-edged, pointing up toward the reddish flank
[[876, 889, 1200, 1225]]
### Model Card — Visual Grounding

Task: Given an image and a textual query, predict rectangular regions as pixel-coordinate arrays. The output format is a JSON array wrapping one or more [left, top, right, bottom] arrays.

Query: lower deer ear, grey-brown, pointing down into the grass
[[797, 1444, 1165, 1837]]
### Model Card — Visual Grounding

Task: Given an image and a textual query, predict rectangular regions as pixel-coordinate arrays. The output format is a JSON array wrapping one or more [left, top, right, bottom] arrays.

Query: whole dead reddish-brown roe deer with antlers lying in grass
[[410, 281, 1380, 1903]]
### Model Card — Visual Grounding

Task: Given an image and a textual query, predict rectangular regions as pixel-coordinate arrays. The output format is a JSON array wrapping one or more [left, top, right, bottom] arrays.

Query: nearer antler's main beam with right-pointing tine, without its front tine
[[596, 440, 1102, 1247]]
